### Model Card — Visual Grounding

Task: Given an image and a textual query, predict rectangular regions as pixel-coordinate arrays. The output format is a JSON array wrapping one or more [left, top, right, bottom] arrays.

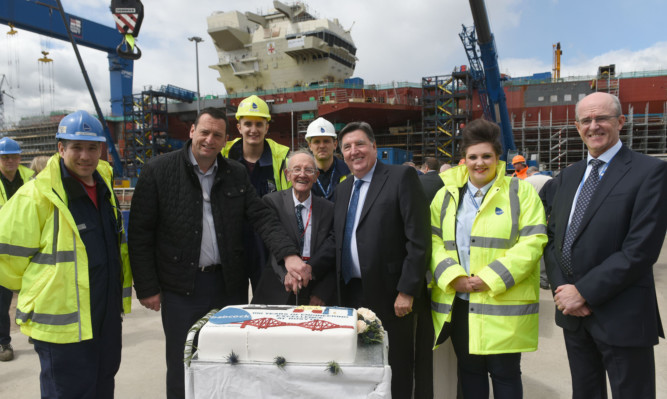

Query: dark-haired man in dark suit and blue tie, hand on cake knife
[[310, 122, 431, 399]]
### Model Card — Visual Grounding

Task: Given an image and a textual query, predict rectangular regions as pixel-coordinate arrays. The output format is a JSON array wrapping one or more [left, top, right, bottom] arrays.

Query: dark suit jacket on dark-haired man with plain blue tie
[[311, 160, 431, 320]]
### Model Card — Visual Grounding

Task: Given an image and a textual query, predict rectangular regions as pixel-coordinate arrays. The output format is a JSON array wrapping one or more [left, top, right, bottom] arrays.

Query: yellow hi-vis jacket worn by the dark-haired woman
[[430, 161, 547, 355]]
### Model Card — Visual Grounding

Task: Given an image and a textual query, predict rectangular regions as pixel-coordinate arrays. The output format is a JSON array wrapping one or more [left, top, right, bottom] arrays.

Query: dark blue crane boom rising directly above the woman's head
[[459, 0, 516, 160]]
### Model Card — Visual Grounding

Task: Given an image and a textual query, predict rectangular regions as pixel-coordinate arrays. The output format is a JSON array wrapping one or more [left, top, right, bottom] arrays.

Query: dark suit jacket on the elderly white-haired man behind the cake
[[252, 189, 336, 305]]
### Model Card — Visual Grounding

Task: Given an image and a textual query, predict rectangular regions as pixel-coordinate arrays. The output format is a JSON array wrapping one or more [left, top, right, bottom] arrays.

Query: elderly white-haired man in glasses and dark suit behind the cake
[[252, 150, 336, 306]]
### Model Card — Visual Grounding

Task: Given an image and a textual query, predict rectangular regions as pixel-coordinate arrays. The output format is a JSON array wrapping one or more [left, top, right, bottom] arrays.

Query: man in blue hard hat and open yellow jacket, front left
[[0, 111, 132, 398]]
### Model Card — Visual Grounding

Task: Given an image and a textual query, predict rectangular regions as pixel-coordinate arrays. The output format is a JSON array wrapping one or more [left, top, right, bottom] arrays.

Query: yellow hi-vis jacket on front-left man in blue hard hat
[[0, 154, 132, 344]]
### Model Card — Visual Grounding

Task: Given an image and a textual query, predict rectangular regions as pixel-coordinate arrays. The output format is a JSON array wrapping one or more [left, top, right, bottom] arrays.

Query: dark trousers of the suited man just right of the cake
[[343, 279, 415, 399]]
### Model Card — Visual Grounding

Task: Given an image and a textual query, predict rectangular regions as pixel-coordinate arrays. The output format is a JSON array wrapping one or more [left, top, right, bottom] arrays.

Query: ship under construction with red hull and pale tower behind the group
[[0, 1, 667, 176]]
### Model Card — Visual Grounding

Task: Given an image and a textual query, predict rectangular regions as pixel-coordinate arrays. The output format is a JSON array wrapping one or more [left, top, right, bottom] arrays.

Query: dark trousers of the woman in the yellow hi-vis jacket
[[452, 297, 523, 399]]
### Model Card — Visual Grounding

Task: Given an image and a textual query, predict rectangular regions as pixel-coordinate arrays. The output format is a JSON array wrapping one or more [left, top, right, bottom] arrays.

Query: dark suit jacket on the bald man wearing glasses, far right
[[544, 146, 667, 347]]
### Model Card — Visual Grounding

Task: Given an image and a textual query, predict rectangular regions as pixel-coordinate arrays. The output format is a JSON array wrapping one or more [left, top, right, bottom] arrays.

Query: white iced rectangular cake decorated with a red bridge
[[197, 305, 357, 363]]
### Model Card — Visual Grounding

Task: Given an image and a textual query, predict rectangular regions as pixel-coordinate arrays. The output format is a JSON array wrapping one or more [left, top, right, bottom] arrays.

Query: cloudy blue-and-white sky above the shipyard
[[0, 0, 667, 122]]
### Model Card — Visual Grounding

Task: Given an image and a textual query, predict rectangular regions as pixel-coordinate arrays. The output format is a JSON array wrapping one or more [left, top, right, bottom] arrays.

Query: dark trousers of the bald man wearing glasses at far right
[[563, 326, 656, 399]]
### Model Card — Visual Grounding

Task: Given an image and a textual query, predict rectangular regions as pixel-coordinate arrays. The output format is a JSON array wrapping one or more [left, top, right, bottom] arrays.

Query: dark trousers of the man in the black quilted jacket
[[162, 270, 248, 399]]
